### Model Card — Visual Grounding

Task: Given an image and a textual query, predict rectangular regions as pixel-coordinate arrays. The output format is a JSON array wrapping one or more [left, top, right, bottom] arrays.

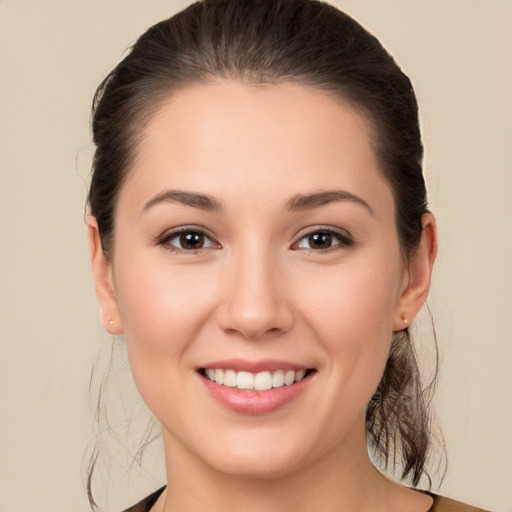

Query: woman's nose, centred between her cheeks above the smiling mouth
[[218, 250, 293, 340]]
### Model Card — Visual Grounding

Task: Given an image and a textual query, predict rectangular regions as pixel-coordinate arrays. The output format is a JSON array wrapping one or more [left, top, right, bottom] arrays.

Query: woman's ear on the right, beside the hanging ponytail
[[393, 213, 437, 331]]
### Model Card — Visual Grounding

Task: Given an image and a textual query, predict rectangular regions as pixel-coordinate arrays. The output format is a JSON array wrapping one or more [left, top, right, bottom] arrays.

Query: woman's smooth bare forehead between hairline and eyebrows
[[121, 81, 392, 214]]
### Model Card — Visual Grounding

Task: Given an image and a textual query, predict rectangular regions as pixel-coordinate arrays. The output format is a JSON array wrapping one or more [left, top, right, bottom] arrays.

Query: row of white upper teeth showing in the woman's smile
[[205, 368, 306, 391]]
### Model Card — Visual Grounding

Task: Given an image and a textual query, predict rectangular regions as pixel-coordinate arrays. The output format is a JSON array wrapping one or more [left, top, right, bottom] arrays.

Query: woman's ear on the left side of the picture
[[87, 217, 124, 334]]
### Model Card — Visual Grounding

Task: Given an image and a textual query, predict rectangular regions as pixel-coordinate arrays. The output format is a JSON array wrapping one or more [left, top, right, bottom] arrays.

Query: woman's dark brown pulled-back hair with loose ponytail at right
[[88, 0, 440, 503]]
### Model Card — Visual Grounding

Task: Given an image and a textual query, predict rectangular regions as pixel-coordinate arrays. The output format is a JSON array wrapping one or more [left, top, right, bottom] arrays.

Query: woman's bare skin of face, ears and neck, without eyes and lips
[[88, 81, 436, 512]]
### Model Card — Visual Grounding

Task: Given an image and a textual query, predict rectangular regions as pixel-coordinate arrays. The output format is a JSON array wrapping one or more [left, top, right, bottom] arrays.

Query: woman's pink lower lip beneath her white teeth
[[200, 375, 312, 415]]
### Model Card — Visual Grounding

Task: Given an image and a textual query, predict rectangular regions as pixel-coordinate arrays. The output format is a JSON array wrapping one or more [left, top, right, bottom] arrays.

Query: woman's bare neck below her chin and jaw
[[157, 424, 390, 512]]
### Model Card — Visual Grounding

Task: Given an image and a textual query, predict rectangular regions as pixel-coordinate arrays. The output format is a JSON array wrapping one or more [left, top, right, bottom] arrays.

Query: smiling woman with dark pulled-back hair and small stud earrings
[[88, 0, 488, 512]]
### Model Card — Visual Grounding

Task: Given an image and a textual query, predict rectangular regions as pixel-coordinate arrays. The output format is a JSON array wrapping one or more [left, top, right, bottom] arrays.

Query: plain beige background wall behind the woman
[[0, 0, 512, 512]]
